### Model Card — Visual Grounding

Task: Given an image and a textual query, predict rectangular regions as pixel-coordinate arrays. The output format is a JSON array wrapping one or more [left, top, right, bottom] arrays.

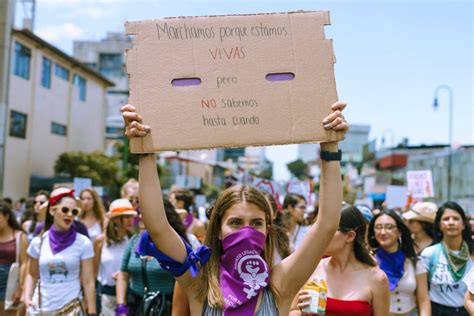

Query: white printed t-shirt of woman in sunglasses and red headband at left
[[28, 231, 94, 312]]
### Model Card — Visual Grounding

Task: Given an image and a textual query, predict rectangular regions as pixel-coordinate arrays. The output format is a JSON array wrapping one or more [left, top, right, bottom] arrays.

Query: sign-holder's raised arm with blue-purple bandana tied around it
[[122, 104, 191, 287]]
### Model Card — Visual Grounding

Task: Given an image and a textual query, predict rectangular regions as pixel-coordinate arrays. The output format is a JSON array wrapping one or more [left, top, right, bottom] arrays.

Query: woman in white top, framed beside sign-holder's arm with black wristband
[[283, 193, 311, 250]]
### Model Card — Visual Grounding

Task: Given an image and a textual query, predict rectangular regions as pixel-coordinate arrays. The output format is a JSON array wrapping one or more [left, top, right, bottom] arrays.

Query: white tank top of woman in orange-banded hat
[[97, 239, 128, 286]]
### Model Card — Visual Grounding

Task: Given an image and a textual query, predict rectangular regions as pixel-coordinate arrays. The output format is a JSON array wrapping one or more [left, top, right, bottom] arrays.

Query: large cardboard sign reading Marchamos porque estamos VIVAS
[[125, 12, 342, 153]]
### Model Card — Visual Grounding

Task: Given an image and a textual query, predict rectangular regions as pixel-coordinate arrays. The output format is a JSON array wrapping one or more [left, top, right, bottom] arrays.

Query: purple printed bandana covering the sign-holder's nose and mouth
[[220, 227, 269, 316]]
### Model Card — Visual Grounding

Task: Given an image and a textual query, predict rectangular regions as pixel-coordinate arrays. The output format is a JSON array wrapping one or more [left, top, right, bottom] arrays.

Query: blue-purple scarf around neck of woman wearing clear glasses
[[375, 248, 405, 292]]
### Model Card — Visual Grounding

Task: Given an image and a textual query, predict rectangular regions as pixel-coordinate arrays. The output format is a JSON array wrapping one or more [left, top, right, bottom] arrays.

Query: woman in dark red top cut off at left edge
[[0, 201, 28, 315]]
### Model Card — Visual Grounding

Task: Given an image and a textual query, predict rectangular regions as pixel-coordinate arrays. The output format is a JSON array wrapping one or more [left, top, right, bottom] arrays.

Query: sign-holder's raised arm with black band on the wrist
[[273, 102, 348, 298]]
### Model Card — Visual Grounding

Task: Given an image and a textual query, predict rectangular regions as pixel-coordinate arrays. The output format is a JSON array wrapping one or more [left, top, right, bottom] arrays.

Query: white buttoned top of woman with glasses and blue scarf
[[390, 258, 427, 314]]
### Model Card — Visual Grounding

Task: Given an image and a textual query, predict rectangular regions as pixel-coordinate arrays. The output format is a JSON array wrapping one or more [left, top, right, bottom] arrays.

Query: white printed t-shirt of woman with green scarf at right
[[421, 245, 472, 307]]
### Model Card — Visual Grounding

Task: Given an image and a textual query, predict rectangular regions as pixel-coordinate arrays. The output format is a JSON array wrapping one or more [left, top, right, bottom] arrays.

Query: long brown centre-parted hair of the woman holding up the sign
[[196, 185, 278, 308]]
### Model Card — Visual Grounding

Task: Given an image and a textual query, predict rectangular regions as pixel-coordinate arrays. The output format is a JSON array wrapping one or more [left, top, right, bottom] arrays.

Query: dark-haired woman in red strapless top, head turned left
[[290, 204, 390, 316]]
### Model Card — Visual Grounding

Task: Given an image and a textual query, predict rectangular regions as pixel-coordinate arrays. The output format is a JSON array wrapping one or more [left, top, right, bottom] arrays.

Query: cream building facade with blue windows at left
[[1, 29, 113, 199]]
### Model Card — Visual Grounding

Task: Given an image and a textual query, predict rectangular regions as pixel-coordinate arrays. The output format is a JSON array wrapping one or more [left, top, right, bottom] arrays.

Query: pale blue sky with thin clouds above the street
[[12, 0, 474, 179]]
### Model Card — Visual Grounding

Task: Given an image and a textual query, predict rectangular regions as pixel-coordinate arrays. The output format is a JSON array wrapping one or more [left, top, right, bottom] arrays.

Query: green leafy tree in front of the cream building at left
[[54, 151, 118, 186]]
